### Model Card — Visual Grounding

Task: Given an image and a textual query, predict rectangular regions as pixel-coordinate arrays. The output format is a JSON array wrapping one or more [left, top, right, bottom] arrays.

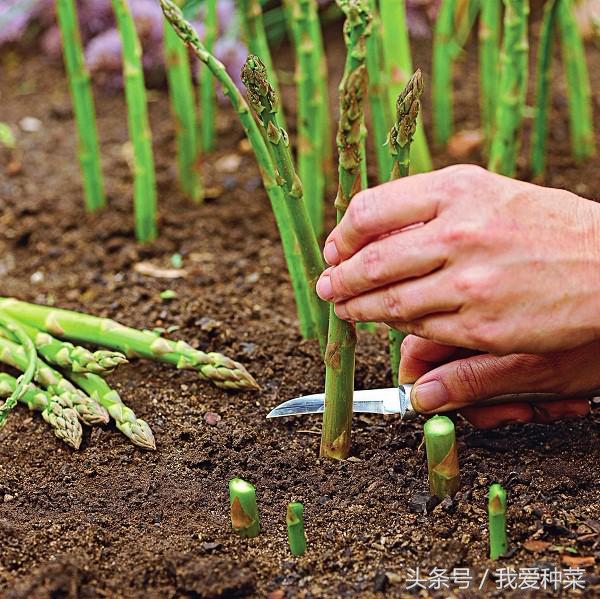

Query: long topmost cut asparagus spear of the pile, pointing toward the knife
[[0, 298, 258, 389]]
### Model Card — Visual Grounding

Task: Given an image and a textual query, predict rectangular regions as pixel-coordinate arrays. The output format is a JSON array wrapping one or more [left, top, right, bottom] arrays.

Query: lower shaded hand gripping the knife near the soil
[[399, 335, 600, 428]]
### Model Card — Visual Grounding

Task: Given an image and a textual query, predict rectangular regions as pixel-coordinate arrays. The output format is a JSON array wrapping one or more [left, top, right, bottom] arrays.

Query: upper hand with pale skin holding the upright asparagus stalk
[[317, 165, 600, 354]]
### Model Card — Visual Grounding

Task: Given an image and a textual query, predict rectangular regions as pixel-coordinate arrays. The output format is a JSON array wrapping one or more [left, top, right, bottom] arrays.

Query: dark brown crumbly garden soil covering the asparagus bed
[[0, 16, 600, 598]]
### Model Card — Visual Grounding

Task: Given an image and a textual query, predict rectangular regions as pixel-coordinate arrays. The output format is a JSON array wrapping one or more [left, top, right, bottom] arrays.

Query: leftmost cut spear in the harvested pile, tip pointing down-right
[[0, 372, 82, 449]]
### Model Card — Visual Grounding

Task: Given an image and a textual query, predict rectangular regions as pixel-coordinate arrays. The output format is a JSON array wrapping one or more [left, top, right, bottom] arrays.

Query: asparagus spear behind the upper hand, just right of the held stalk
[[387, 69, 423, 386]]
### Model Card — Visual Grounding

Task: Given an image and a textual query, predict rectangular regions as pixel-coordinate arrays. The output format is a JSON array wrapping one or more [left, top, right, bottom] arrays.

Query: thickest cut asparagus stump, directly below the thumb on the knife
[[423, 416, 460, 499]]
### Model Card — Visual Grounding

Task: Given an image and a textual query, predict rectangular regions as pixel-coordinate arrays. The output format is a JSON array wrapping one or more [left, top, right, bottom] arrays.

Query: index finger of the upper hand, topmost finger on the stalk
[[323, 172, 440, 265]]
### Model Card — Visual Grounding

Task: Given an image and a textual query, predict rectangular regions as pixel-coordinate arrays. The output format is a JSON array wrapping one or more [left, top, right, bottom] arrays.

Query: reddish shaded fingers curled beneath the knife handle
[[460, 399, 590, 429]]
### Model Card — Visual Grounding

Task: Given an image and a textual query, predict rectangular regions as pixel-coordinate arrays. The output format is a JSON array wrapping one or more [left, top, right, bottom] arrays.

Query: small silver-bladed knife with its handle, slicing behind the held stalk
[[267, 385, 600, 418]]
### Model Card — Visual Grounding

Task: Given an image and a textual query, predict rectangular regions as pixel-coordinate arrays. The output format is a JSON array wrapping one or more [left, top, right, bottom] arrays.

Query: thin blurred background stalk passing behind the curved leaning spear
[[199, 0, 219, 152]]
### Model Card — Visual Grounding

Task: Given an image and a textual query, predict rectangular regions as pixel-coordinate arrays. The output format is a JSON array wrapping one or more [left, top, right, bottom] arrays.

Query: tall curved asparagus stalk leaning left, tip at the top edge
[[160, 0, 314, 338]]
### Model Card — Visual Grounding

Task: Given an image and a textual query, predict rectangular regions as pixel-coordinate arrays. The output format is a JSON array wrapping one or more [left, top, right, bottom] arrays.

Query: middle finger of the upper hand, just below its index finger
[[317, 223, 445, 302]]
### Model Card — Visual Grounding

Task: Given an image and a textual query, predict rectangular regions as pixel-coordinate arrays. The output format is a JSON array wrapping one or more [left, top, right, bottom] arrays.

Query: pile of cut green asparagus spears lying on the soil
[[0, 298, 258, 449]]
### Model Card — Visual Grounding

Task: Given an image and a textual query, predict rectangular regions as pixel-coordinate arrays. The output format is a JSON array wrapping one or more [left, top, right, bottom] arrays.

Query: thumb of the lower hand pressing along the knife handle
[[411, 354, 559, 412]]
